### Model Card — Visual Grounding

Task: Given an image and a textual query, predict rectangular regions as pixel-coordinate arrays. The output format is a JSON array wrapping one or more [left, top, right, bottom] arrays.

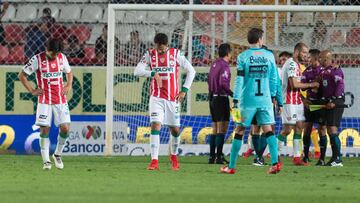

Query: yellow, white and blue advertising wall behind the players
[[0, 66, 360, 156]]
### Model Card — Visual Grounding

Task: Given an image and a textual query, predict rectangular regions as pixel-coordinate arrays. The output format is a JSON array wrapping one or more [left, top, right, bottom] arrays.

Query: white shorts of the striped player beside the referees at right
[[281, 104, 305, 125]]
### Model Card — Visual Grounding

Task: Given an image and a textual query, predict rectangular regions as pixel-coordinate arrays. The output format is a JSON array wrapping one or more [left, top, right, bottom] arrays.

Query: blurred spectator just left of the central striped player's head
[[124, 30, 146, 65]]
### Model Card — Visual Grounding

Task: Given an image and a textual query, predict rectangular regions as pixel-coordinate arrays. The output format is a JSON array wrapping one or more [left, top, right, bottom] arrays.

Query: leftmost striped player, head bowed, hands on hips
[[19, 39, 73, 170]]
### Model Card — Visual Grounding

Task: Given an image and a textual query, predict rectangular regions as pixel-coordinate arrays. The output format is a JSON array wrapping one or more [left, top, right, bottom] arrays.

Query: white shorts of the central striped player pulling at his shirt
[[149, 97, 180, 127]]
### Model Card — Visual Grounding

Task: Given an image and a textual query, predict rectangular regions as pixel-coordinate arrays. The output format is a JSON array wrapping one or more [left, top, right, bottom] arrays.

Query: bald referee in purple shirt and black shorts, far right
[[318, 50, 345, 166]]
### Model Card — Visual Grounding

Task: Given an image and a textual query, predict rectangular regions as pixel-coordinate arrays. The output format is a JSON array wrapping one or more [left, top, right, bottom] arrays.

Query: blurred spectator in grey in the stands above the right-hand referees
[[311, 20, 329, 50]]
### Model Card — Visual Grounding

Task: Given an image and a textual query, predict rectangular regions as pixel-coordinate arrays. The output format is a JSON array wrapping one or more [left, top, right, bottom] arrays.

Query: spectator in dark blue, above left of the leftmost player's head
[[24, 19, 49, 59]]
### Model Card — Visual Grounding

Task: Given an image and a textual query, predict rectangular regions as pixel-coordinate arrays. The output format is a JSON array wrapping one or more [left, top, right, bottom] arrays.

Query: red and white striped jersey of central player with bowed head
[[135, 48, 195, 101]]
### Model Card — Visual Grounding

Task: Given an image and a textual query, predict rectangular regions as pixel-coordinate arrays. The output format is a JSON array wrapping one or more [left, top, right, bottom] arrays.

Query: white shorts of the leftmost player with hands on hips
[[35, 103, 71, 127]]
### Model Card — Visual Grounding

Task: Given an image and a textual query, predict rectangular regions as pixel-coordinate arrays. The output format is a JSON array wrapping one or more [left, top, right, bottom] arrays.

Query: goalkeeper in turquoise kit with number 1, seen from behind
[[220, 28, 280, 174]]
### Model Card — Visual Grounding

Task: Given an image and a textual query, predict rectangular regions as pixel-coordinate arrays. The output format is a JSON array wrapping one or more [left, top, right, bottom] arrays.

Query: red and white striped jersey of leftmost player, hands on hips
[[23, 52, 71, 104]]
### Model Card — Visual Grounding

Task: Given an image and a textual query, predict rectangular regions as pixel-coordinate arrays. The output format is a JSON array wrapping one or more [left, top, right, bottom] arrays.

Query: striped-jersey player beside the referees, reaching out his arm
[[278, 43, 319, 165]]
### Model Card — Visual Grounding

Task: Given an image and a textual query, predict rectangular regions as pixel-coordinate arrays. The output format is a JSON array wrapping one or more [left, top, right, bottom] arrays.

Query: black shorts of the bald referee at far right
[[322, 98, 345, 127]]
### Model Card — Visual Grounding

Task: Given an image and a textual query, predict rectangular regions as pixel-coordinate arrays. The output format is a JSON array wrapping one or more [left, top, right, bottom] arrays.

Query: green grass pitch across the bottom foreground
[[0, 155, 360, 203]]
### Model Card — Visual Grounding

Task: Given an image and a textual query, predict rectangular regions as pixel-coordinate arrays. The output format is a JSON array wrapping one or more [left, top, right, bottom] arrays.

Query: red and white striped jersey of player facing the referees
[[282, 58, 302, 104]]
